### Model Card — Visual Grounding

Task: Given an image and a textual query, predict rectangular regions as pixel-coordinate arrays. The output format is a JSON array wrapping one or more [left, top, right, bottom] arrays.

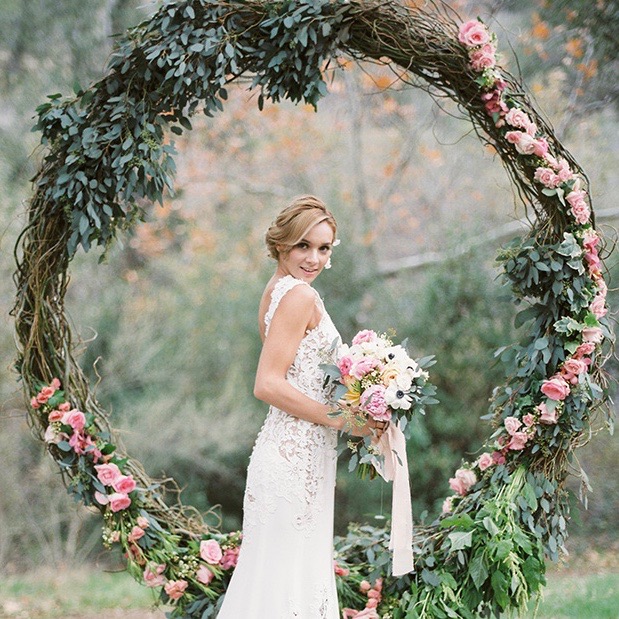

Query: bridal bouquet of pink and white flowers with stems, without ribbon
[[322, 329, 437, 478]]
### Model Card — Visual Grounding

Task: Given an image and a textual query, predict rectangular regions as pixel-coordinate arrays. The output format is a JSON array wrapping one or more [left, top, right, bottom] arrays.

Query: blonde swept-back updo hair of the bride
[[265, 196, 337, 260]]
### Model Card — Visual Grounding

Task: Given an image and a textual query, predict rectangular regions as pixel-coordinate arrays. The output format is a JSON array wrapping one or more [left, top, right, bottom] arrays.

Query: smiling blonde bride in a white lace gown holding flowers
[[218, 196, 381, 619]]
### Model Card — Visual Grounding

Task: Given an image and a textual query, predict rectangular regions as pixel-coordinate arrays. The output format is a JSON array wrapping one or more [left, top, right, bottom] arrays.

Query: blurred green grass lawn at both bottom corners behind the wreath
[[0, 562, 619, 619]]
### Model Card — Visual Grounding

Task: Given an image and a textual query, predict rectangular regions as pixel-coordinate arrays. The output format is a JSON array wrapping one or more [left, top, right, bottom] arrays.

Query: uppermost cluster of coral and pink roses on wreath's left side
[[30, 378, 101, 462]]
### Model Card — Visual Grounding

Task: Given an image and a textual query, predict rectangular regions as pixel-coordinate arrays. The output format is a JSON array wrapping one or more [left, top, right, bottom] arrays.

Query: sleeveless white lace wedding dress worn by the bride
[[217, 275, 339, 619]]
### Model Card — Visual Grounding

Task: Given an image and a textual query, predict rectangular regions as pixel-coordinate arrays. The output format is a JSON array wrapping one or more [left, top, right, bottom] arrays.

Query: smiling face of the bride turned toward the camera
[[278, 221, 333, 284]]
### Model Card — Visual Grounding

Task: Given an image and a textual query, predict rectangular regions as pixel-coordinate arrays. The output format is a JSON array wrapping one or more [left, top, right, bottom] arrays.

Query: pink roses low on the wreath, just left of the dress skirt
[[143, 539, 240, 600]]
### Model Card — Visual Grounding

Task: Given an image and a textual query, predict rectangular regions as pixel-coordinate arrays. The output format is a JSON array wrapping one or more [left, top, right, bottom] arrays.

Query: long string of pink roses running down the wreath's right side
[[443, 20, 608, 494]]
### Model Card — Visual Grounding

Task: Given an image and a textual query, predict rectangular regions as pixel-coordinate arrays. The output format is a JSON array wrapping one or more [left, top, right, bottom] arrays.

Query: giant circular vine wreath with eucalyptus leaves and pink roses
[[14, 0, 612, 619]]
